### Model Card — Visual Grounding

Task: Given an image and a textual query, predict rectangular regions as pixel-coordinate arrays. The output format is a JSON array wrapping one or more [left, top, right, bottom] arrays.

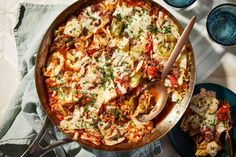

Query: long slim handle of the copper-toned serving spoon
[[161, 16, 196, 80]]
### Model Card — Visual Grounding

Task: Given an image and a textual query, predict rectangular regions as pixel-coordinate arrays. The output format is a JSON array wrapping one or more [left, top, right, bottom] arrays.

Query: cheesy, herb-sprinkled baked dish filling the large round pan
[[43, 0, 192, 146]]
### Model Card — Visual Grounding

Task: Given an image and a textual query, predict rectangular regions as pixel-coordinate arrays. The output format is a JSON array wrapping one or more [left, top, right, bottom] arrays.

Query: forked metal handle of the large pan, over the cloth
[[21, 118, 73, 157]]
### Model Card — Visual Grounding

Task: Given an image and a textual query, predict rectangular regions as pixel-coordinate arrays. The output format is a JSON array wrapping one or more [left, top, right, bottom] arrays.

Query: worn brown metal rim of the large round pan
[[35, 0, 196, 152]]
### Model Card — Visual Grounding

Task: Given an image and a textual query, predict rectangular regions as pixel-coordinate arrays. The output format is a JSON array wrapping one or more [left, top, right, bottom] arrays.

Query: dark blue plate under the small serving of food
[[168, 83, 236, 157]]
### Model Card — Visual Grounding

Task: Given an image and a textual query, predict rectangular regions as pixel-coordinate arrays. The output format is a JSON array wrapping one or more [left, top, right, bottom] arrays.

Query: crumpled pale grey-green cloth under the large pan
[[0, 3, 161, 157]]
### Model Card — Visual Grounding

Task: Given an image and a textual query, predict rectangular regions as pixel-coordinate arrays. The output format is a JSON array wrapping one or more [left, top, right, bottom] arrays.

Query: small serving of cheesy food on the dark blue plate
[[180, 88, 231, 156]]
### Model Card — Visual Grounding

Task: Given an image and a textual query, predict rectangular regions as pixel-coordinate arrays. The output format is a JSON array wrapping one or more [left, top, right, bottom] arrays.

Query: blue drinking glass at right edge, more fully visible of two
[[206, 4, 236, 46]]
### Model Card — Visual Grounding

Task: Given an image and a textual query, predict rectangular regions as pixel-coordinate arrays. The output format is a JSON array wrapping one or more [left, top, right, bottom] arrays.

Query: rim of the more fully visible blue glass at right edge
[[206, 3, 236, 46]]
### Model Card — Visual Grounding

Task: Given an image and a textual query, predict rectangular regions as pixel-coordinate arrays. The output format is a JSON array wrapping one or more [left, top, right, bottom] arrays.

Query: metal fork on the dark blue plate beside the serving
[[221, 100, 233, 157]]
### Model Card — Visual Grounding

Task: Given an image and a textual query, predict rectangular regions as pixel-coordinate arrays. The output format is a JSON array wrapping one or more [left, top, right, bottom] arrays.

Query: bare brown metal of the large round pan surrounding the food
[[35, 0, 196, 151]]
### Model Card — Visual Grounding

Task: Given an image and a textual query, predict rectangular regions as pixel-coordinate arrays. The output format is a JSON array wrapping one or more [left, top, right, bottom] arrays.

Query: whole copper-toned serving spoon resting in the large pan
[[136, 16, 196, 122]]
